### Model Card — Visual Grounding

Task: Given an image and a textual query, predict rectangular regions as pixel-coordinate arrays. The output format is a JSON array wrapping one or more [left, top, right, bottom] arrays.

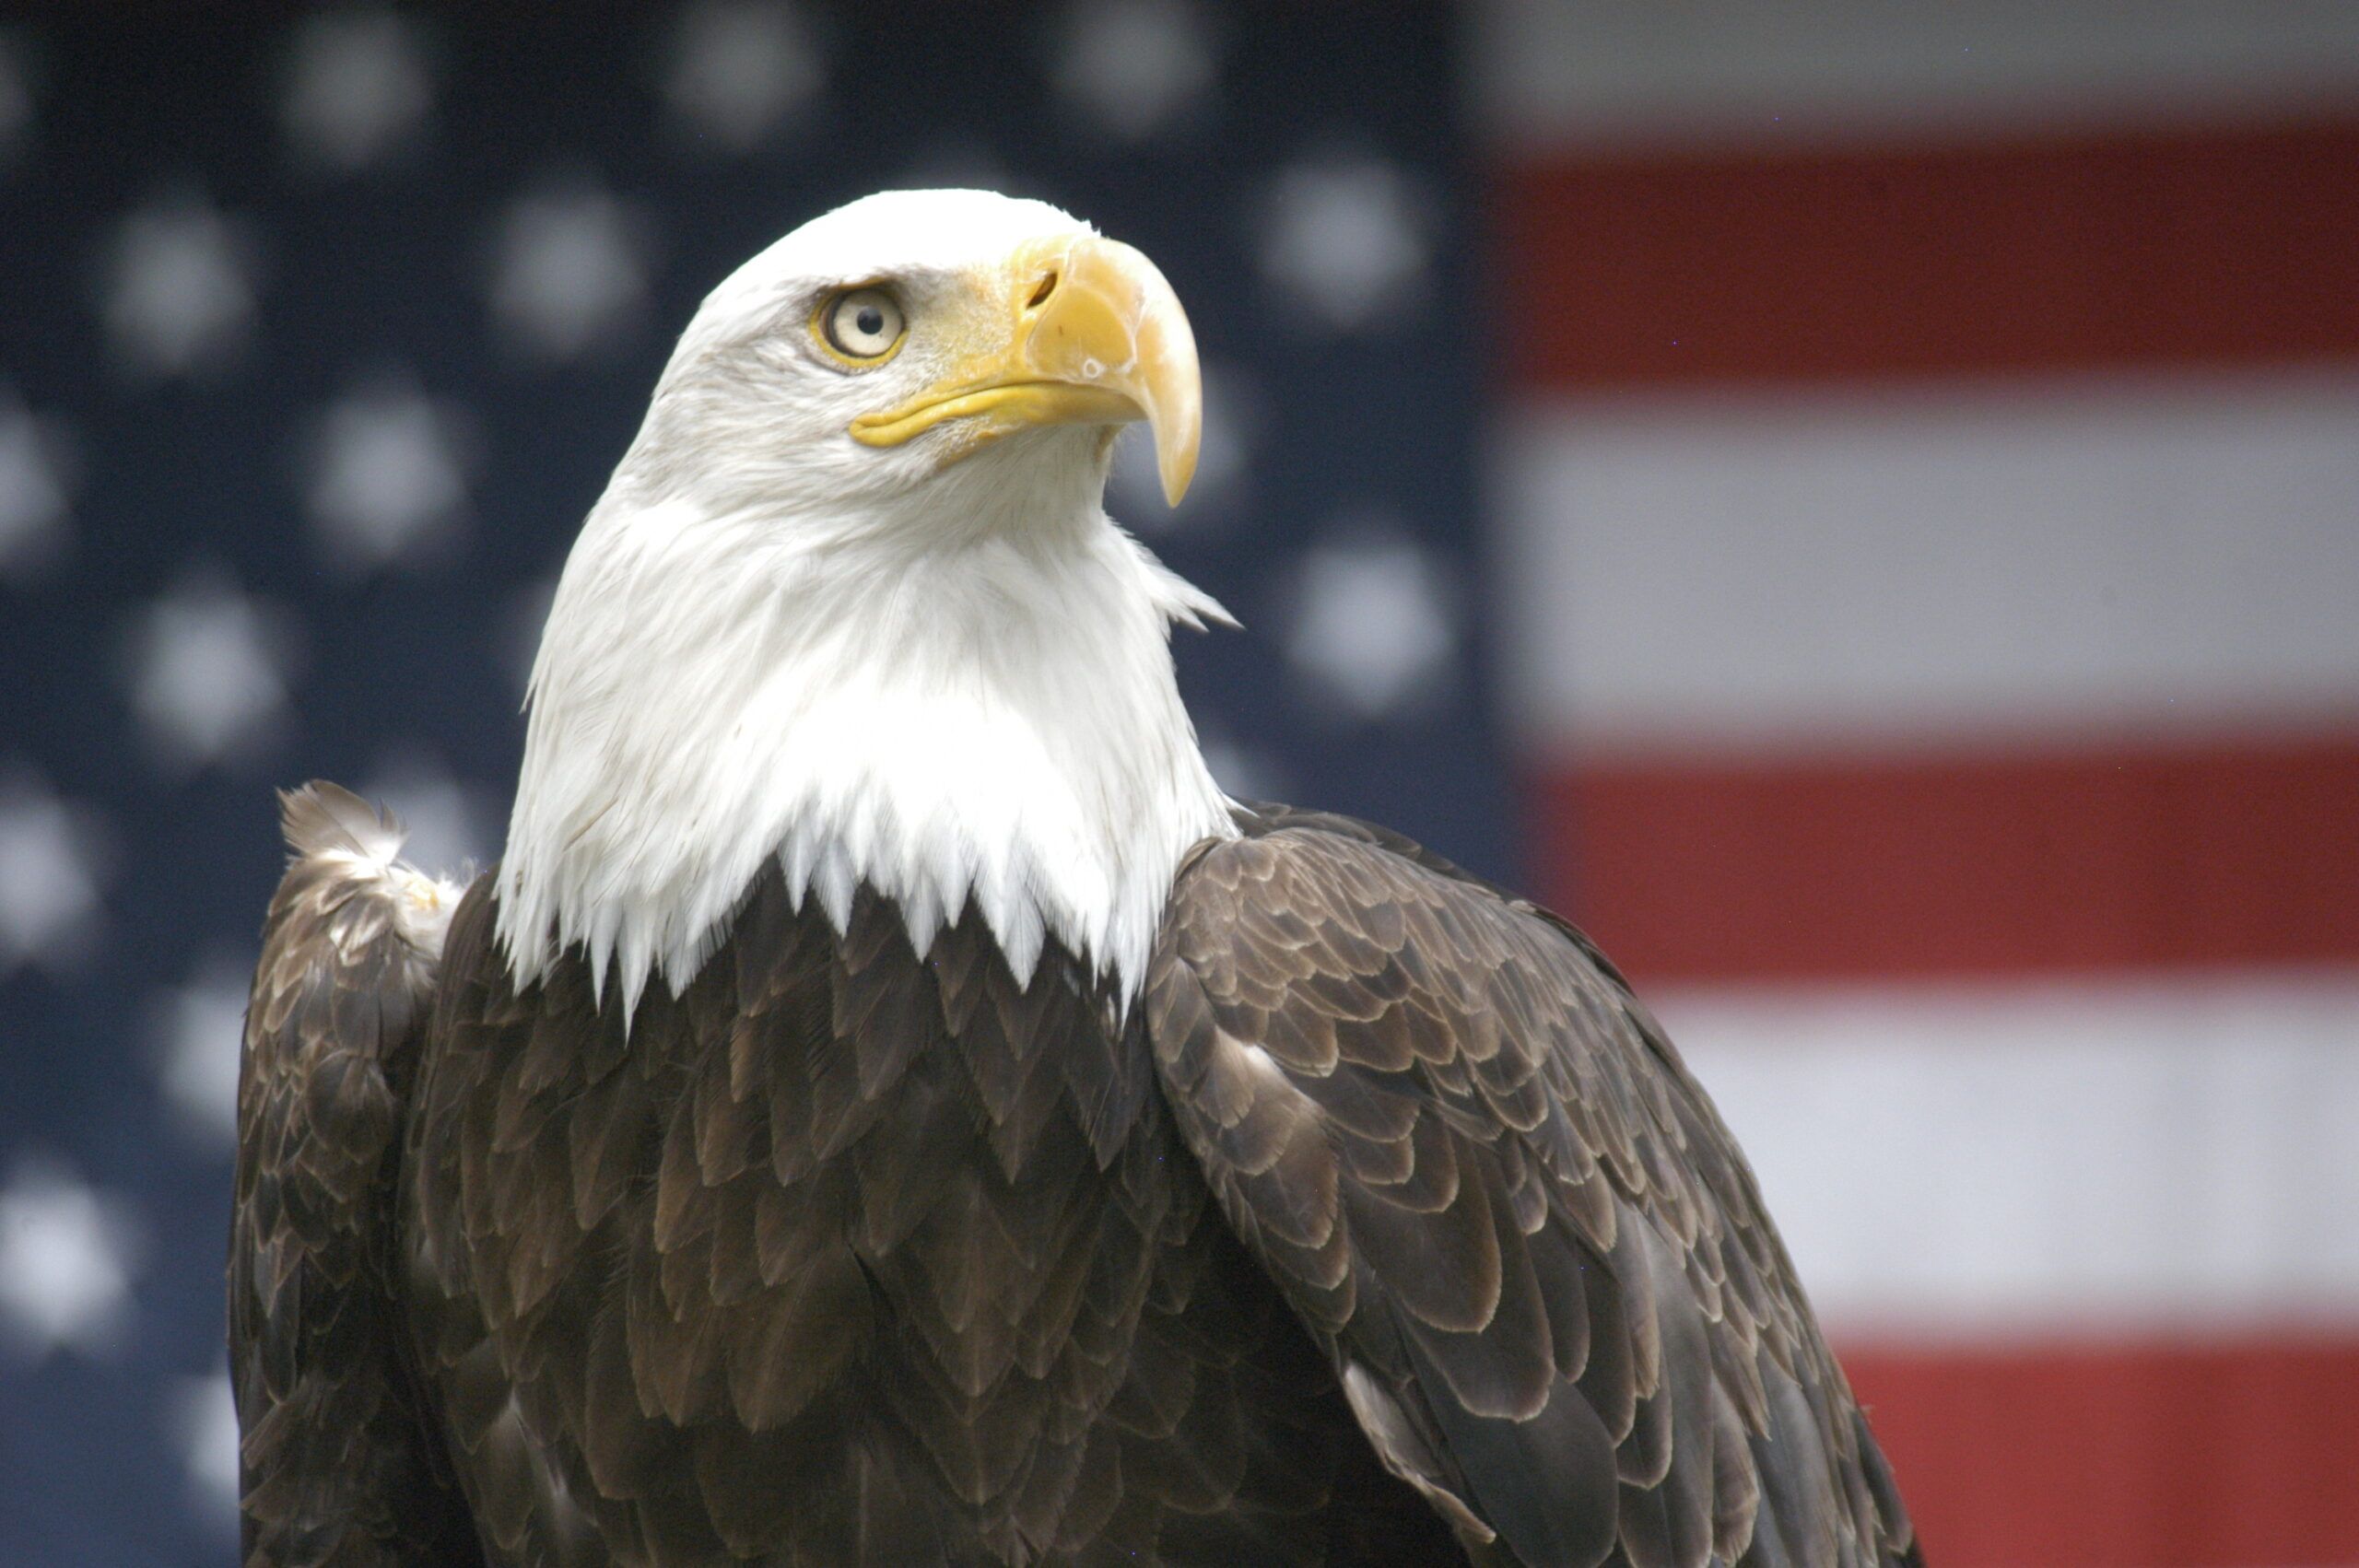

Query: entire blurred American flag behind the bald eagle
[[0, 0, 2359, 1568]]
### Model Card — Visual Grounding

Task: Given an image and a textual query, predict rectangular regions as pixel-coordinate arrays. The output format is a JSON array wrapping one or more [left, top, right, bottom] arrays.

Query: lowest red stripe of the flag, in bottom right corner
[[1842, 1340, 2359, 1568]]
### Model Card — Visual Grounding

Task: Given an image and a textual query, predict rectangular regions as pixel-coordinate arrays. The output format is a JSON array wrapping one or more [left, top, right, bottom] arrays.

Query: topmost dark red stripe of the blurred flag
[[1493, 123, 2359, 389]]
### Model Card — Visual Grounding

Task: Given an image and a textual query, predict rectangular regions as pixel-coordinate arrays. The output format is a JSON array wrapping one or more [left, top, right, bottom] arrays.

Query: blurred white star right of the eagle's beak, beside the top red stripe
[[1262, 158, 1429, 333]]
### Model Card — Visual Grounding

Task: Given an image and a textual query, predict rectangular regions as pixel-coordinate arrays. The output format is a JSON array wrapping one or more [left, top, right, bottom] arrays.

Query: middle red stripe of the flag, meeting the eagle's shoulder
[[1531, 738, 2359, 983]]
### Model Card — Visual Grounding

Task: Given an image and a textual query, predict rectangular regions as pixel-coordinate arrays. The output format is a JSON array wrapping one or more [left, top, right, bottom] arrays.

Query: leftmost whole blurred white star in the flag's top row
[[278, 9, 434, 172]]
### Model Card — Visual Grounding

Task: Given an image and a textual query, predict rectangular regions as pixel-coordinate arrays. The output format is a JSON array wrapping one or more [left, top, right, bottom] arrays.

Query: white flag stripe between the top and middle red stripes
[[1498, 372, 2359, 747]]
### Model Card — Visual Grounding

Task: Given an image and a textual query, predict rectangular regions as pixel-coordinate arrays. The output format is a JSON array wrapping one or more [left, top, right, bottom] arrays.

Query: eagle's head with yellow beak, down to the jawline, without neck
[[640, 191, 1203, 523]]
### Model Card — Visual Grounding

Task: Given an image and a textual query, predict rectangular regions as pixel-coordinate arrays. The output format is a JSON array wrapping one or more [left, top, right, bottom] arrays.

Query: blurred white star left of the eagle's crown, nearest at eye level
[[490, 184, 646, 361]]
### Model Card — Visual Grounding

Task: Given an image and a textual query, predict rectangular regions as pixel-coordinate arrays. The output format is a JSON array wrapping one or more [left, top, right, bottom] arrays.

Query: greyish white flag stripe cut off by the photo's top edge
[[1474, 0, 2359, 148]]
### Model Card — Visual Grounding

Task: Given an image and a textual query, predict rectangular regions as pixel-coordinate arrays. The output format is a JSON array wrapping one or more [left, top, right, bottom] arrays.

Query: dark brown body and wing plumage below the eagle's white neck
[[231, 788, 1918, 1568]]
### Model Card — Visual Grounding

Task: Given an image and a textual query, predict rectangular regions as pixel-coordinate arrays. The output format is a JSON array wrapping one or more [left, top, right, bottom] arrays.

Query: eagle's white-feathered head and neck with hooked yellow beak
[[500, 191, 1234, 1004]]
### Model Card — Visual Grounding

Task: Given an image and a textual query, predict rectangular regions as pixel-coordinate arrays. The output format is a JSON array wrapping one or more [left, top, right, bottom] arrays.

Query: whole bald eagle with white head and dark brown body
[[229, 191, 1918, 1568]]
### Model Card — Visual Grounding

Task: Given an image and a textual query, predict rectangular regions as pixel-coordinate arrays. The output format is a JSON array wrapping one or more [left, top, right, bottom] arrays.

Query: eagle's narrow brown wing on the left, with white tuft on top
[[229, 783, 481, 1568]]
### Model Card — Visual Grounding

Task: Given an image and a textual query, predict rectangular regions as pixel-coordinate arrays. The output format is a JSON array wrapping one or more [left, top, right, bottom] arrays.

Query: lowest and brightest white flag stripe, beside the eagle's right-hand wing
[[1659, 971, 2359, 1337]]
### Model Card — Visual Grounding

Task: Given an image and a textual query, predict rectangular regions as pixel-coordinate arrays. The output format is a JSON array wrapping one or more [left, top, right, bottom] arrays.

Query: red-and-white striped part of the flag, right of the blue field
[[1479, 0, 2359, 1568]]
